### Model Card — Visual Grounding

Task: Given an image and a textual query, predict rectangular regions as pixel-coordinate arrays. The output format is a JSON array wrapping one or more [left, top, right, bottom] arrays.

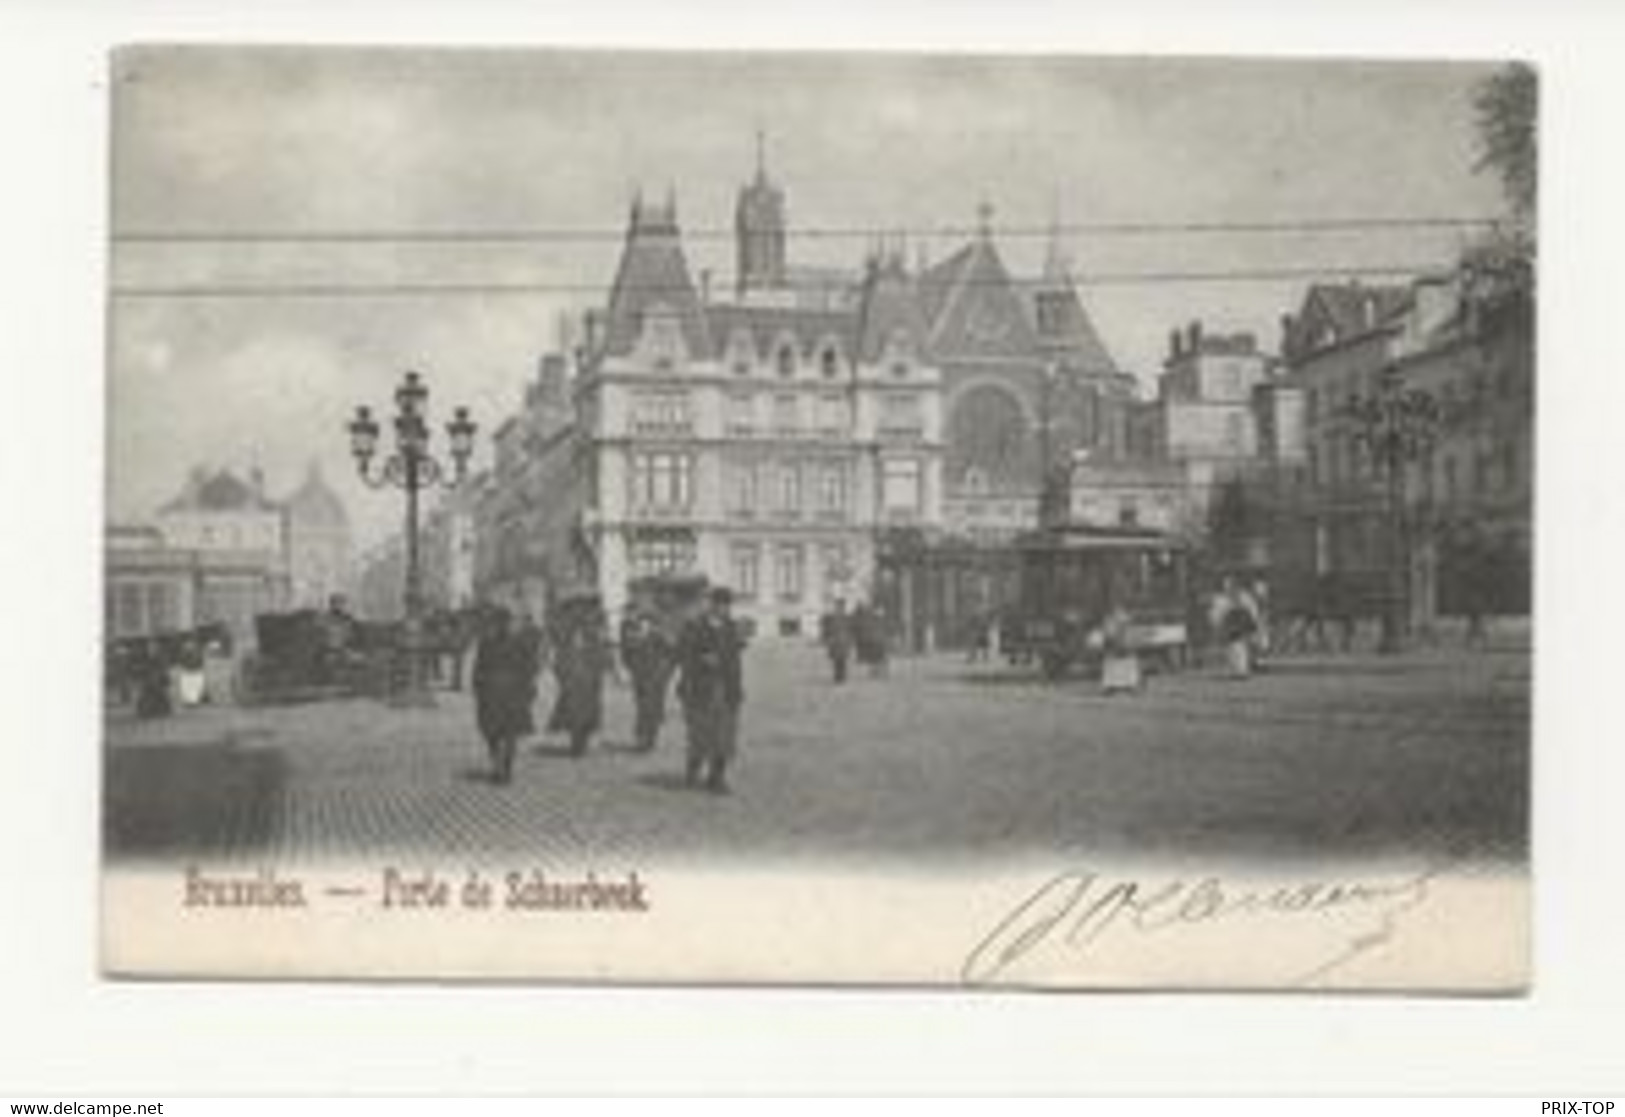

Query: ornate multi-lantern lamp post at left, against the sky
[[349, 372, 478, 706]]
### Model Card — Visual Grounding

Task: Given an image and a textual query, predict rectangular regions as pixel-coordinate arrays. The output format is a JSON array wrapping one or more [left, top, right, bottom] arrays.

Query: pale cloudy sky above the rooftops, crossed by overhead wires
[[111, 49, 1500, 540]]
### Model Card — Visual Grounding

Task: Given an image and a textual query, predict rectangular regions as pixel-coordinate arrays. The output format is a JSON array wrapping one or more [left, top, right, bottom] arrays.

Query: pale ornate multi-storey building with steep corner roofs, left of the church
[[578, 191, 943, 636]]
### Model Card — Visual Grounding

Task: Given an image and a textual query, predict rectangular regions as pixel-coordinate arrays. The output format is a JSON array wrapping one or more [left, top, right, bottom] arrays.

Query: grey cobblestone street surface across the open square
[[107, 645, 1529, 863]]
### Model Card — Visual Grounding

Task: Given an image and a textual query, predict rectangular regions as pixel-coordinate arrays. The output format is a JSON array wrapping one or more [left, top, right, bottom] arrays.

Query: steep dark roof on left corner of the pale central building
[[605, 200, 710, 356]]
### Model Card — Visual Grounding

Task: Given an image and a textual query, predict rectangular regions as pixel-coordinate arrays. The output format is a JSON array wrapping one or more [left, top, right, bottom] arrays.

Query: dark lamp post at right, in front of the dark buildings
[[1349, 366, 1438, 652]]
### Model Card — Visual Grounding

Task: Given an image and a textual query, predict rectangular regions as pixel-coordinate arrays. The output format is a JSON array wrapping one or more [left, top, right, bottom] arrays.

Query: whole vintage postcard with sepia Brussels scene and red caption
[[101, 46, 1537, 992]]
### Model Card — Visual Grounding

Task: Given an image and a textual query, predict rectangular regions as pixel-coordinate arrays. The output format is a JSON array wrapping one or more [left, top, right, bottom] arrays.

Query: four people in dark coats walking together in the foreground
[[473, 587, 744, 793]]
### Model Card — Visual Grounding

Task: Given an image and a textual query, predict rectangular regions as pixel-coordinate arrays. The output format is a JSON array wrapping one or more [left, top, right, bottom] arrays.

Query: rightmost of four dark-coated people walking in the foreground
[[678, 587, 744, 795]]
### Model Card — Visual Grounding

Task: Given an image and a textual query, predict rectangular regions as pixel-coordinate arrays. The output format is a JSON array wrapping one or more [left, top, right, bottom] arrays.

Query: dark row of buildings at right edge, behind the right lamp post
[[1276, 261, 1534, 629]]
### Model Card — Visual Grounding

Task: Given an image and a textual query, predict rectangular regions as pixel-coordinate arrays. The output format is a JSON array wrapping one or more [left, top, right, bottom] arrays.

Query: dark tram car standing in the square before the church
[[1003, 525, 1193, 678]]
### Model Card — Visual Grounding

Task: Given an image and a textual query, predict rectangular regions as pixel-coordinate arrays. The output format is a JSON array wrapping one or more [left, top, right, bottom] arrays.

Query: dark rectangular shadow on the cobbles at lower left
[[102, 745, 288, 858]]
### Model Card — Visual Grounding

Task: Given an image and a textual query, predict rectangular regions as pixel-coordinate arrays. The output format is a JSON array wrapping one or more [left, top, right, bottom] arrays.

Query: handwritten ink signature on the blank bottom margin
[[960, 865, 1448, 985]]
